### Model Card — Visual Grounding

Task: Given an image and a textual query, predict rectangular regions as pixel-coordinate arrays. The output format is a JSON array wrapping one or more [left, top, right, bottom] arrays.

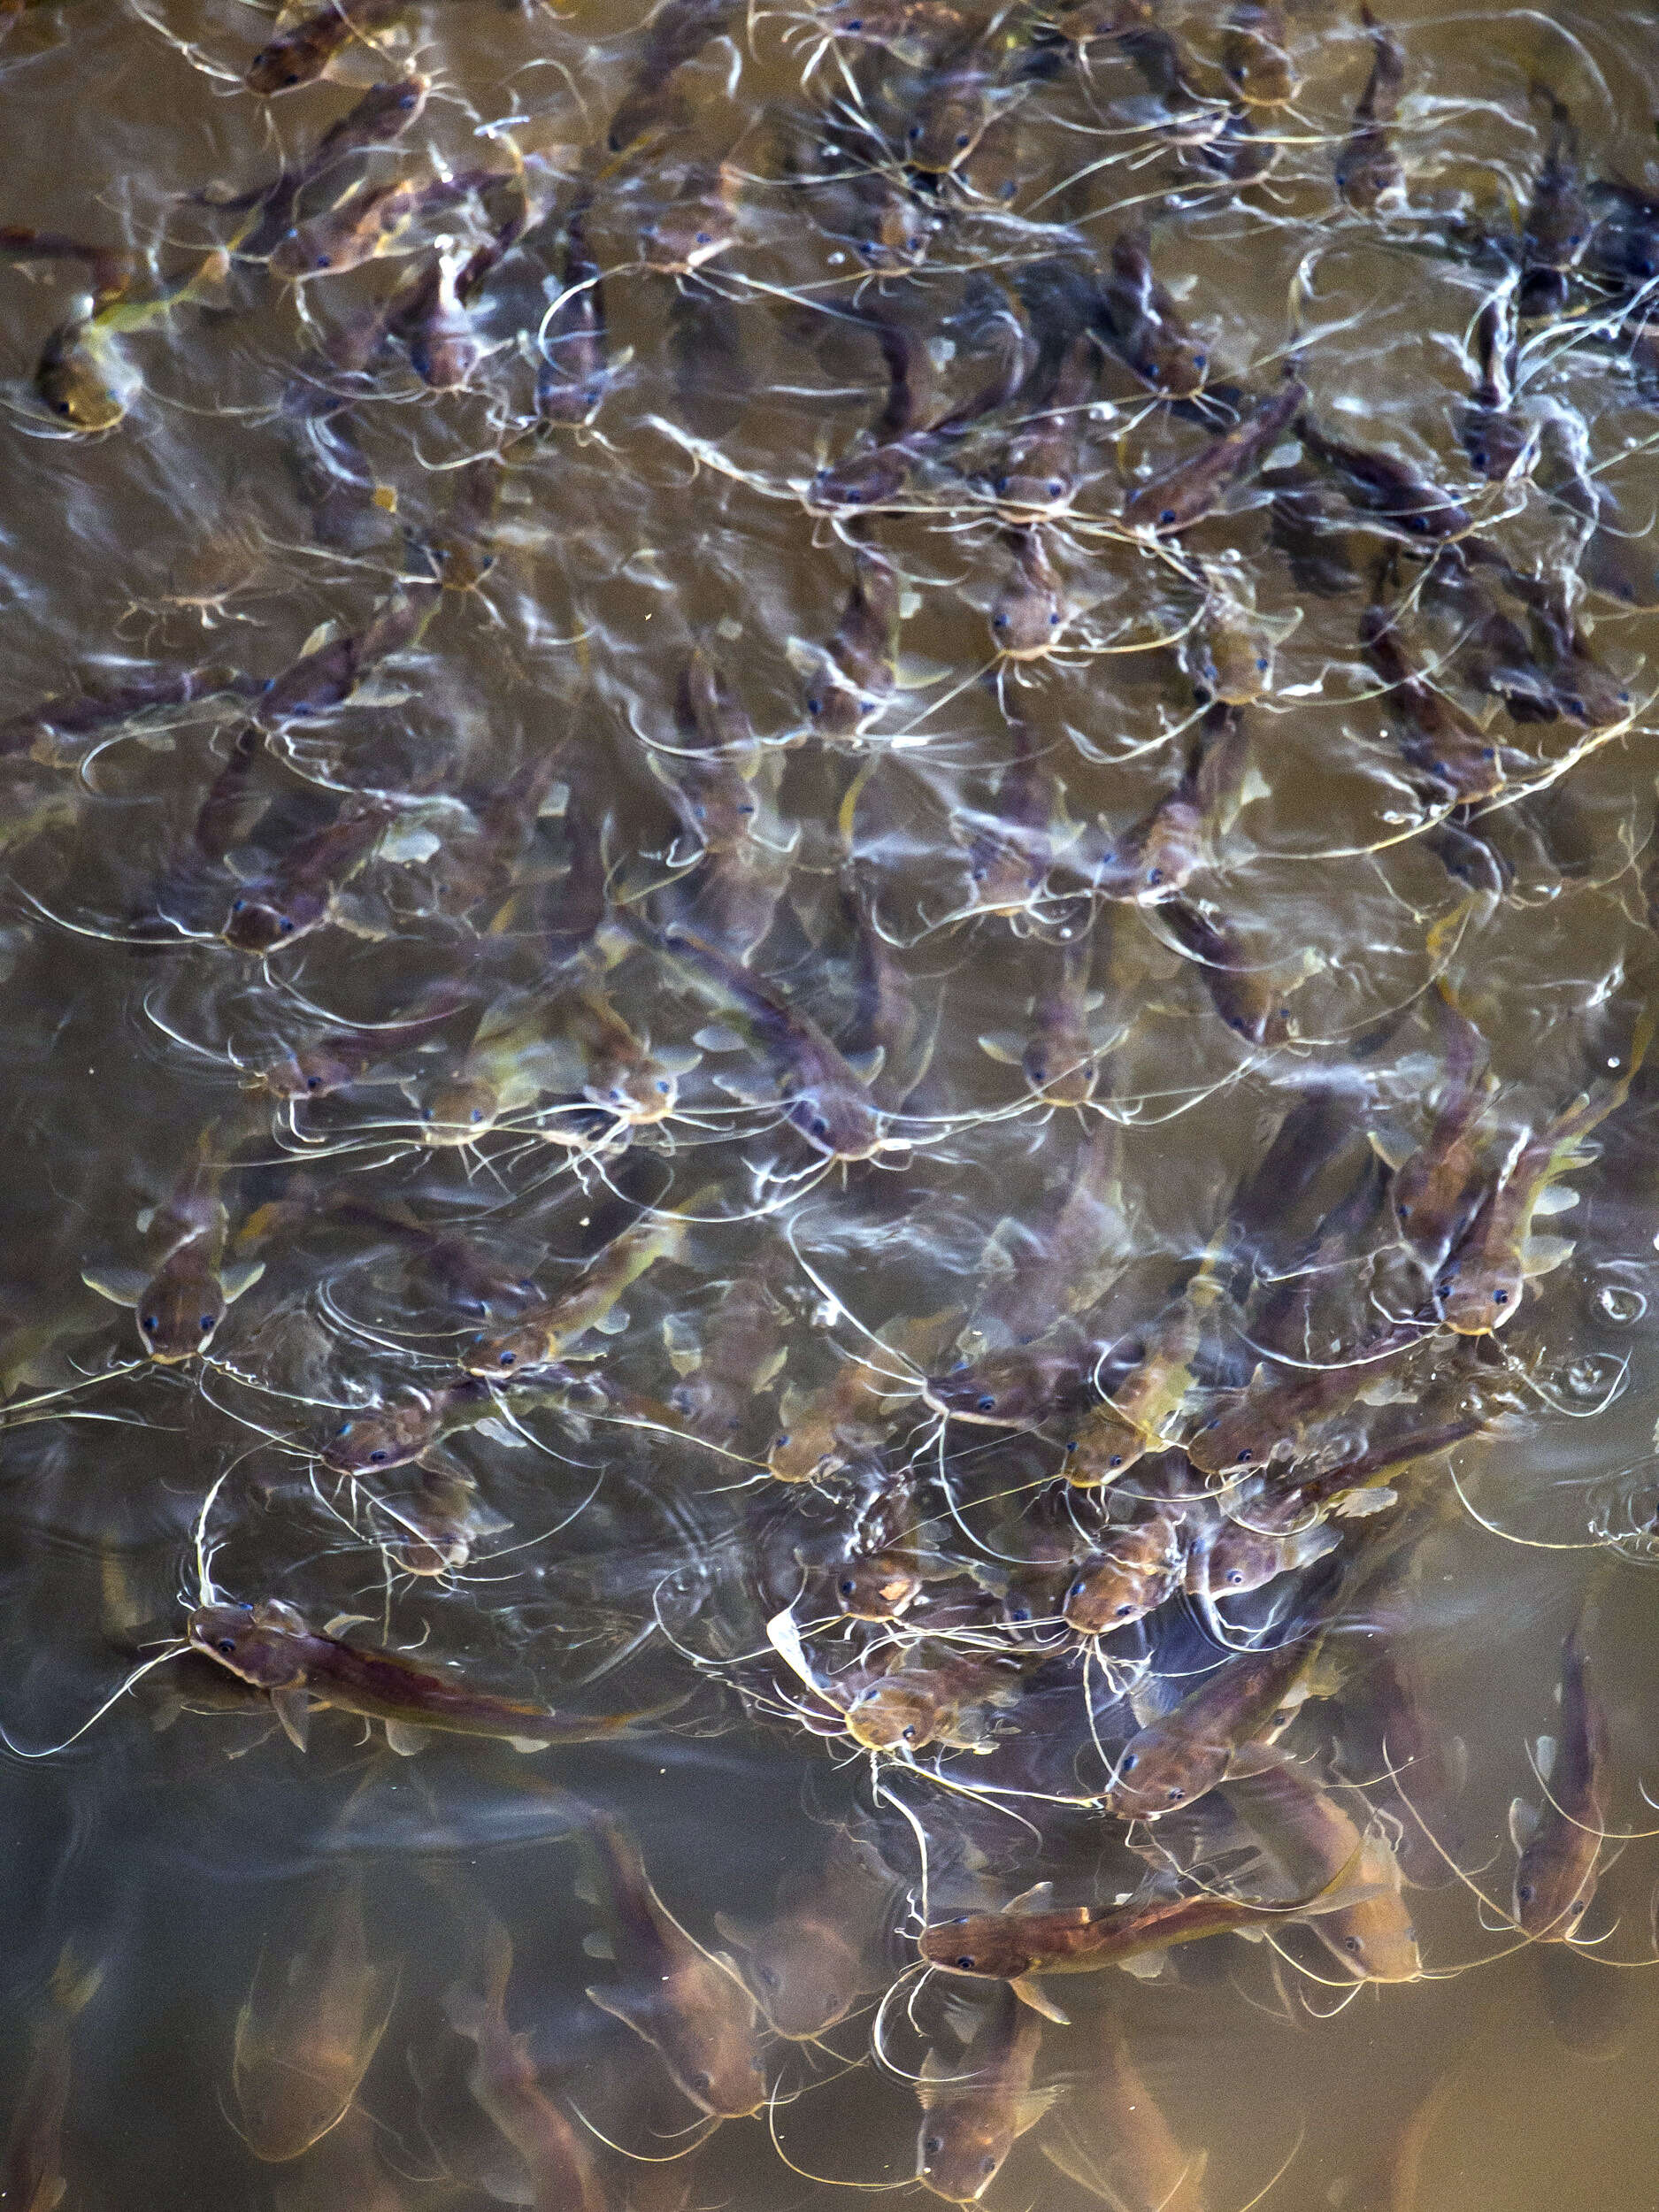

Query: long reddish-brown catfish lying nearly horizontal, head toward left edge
[[184, 1600, 664, 1755]]
